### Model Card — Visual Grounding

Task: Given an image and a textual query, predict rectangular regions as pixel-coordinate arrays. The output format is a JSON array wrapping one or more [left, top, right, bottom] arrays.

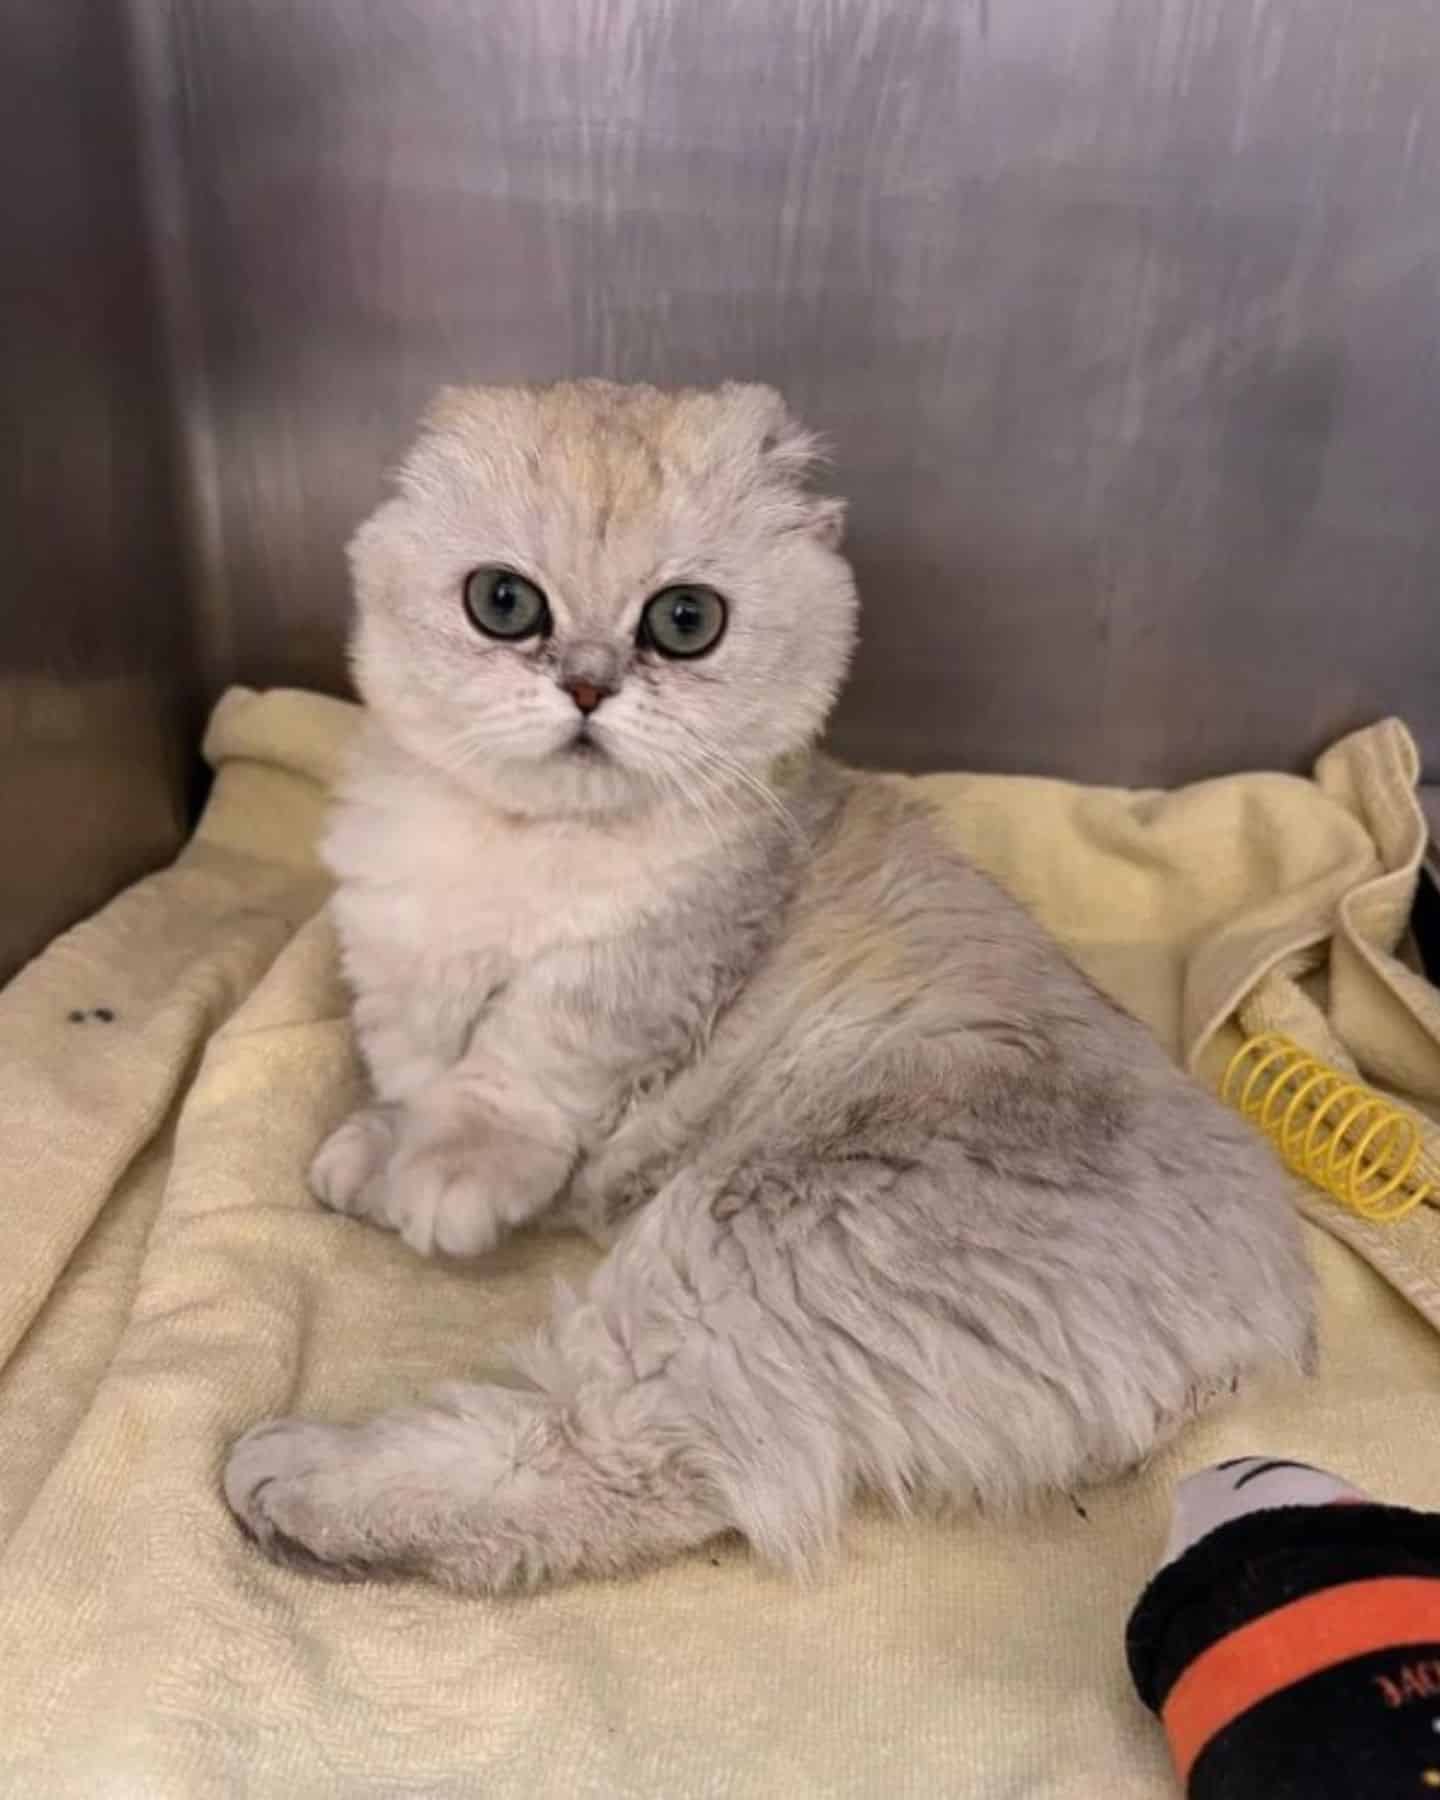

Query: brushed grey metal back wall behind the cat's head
[[135, 0, 1440, 781]]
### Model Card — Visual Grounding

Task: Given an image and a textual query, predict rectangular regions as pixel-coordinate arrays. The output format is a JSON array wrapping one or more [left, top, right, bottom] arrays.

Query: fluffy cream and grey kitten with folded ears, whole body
[[225, 382, 1314, 1593]]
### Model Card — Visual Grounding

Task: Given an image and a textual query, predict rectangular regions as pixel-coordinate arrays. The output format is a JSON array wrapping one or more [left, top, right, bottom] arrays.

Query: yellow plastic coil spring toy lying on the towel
[[1220, 1031, 1431, 1224]]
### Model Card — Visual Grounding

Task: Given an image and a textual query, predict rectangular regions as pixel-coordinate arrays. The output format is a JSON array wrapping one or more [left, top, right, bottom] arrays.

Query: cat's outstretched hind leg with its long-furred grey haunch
[[225, 1145, 1303, 1591]]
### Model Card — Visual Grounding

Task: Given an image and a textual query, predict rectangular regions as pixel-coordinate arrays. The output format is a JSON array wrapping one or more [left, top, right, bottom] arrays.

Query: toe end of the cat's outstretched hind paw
[[225, 1418, 369, 1580]]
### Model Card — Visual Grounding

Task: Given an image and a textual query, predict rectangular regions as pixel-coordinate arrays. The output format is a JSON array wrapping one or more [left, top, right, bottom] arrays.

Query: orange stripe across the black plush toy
[[1161, 1575, 1440, 1782]]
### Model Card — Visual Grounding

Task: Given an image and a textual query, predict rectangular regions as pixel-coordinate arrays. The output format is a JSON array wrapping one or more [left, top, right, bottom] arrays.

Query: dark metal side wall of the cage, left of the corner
[[0, 0, 193, 979]]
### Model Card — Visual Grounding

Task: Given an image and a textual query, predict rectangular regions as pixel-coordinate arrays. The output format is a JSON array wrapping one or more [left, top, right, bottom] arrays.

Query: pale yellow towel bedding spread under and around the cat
[[0, 693, 1440, 1800]]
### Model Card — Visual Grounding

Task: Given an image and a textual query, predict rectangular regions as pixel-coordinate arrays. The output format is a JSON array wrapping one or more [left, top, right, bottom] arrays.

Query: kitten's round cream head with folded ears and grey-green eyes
[[351, 382, 855, 815]]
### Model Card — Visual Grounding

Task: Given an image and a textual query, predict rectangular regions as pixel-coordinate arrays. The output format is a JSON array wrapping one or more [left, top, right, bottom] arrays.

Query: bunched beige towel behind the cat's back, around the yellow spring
[[923, 718, 1440, 1330]]
